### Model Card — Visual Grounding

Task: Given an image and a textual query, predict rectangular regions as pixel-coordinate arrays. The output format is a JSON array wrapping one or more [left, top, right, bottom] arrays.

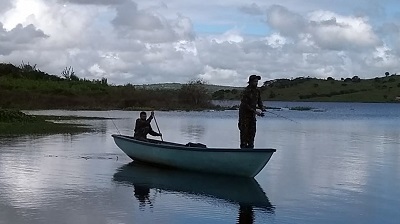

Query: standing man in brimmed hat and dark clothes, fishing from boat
[[238, 75, 265, 148]]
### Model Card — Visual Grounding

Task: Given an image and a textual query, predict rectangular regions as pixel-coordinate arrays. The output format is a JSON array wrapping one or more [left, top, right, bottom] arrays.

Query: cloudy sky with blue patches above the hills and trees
[[0, 0, 400, 86]]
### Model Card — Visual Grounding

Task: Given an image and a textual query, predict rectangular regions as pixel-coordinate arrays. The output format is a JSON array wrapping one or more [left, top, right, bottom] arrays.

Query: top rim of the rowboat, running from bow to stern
[[111, 134, 276, 153]]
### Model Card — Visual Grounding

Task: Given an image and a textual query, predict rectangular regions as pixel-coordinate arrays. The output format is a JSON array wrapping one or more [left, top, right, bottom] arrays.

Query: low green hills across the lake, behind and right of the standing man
[[212, 74, 400, 102]]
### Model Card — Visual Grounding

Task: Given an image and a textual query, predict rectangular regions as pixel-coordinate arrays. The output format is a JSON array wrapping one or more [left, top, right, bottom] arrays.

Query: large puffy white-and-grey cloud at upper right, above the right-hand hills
[[267, 5, 381, 51]]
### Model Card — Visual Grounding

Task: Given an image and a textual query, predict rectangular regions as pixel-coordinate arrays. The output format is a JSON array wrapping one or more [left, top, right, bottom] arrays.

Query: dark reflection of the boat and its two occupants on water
[[113, 162, 275, 223]]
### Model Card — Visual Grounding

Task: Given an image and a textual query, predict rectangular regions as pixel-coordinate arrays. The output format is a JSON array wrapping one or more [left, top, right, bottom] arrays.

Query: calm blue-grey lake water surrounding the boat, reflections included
[[0, 102, 400, 224]]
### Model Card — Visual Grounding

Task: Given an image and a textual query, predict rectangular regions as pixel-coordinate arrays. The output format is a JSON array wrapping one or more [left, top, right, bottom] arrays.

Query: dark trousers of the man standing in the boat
[[238, 116, 256, 148]]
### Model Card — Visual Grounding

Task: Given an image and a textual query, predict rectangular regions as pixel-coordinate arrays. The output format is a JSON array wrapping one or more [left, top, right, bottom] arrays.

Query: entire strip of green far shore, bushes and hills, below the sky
[[0, 63, 400, 111]]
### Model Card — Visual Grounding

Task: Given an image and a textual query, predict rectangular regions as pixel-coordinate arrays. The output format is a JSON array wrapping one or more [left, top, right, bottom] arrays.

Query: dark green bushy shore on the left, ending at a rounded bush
[[0, 63, 215, 110]]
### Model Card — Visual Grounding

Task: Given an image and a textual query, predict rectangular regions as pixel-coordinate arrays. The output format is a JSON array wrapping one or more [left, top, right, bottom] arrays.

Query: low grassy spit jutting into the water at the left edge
[[0, 109, 91, 135]]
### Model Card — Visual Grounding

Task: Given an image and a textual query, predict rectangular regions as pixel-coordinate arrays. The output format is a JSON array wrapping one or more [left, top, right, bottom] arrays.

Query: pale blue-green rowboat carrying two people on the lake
[[112, 134, 276, 177]]
